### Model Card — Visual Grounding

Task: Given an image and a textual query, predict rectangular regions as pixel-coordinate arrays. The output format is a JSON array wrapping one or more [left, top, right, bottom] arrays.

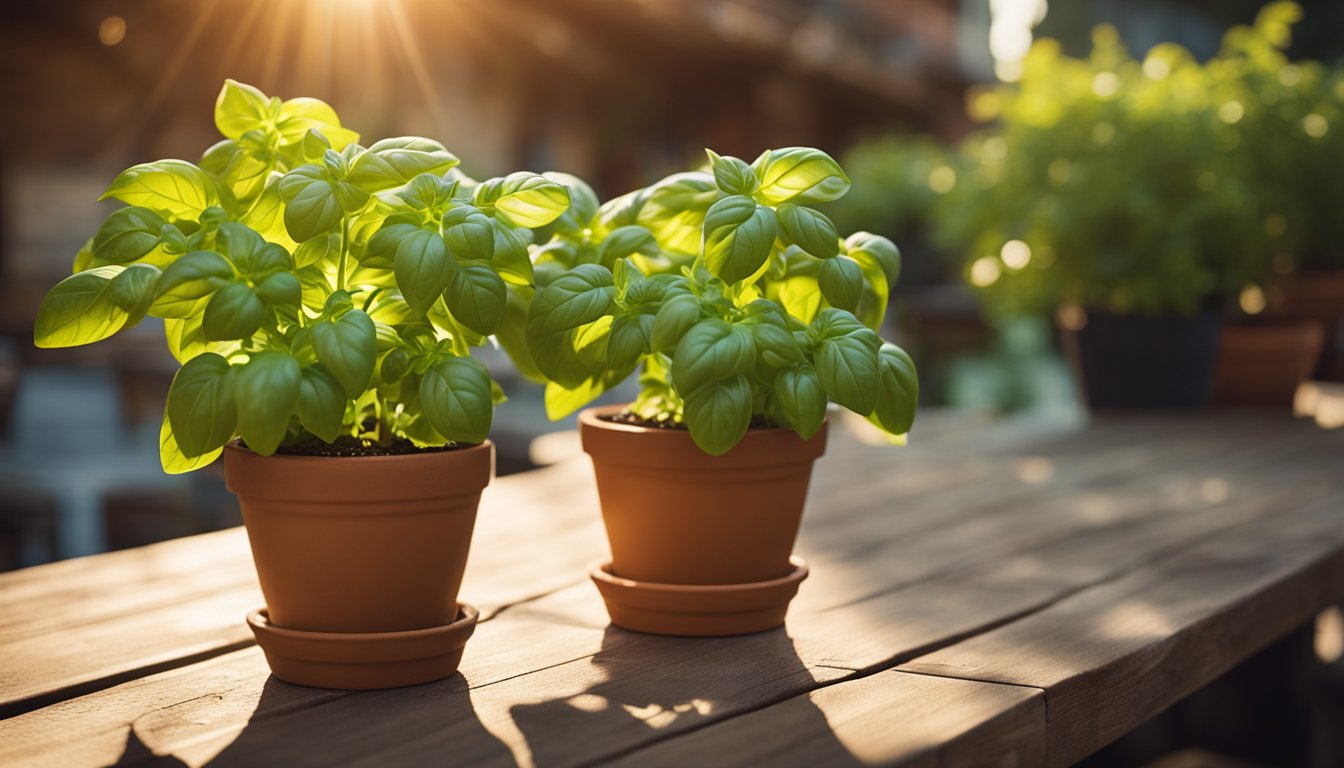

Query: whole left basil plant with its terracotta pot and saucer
[[34, 81, 569, 689]]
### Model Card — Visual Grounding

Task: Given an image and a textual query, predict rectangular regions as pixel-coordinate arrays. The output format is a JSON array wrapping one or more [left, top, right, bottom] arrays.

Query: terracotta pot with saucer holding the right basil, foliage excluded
[[579, 406, 827, 635]]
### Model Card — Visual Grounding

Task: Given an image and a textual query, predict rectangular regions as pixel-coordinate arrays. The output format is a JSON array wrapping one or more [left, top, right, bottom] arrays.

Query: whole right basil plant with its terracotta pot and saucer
[[508, 148, 918, 635]]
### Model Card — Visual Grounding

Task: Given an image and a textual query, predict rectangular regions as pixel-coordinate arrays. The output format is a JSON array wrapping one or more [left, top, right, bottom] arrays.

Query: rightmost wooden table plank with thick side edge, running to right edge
[[900, 496, 1344, 765]]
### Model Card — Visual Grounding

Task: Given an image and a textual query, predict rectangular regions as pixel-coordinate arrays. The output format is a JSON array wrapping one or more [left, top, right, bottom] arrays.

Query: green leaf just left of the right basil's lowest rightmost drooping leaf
[[812, 309, 882, 416]]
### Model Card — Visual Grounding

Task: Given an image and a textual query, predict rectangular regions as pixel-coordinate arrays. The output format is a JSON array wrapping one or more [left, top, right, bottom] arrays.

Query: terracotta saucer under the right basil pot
[[589, 557, 808, 638]]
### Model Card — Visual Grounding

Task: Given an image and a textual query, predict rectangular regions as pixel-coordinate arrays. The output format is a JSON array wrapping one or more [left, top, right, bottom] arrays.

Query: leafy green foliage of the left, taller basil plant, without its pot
[[34, 81, 570, 472]]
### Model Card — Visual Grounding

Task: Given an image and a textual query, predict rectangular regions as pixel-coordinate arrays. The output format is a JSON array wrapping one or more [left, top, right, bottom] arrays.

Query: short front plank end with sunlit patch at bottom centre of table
[[610, 671, 1046, 768]]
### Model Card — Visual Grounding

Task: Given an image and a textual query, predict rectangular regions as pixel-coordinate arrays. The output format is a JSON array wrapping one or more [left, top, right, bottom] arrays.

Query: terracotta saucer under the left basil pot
[[247, 603, 480, 690]]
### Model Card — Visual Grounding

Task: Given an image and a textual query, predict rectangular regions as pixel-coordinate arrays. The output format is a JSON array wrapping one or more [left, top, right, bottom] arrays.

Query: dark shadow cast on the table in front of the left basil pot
[[106, 674, 513, 768]]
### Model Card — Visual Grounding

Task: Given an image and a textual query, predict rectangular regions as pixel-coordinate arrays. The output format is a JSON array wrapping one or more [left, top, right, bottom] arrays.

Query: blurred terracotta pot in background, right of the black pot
[[1214, 320, 1325, 408]]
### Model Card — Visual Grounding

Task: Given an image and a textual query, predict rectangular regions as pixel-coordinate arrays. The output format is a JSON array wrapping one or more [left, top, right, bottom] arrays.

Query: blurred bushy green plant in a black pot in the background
[[938, 26, 1267, 408]]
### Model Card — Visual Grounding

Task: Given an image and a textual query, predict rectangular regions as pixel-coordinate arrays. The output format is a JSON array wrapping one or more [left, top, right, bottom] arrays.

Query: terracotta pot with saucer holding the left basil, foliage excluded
[[224, 443, 493, 687]]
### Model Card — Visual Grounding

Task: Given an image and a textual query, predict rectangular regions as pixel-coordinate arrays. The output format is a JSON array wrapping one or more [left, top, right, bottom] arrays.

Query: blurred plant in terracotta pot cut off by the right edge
[[1225, 3, 1344, 384]]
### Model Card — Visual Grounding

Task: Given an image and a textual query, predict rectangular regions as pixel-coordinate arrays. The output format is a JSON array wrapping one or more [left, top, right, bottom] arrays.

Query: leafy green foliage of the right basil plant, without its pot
[[508, 148, 918, 455]]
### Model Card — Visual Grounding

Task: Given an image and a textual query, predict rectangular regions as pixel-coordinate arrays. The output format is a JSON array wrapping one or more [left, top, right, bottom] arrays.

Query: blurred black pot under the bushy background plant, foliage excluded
[[1060, 311, 1223, 409]]
